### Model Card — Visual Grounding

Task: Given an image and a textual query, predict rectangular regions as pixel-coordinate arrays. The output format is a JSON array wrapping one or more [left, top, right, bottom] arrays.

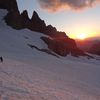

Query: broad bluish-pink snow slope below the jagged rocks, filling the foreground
[[0, 10, 100, 100]]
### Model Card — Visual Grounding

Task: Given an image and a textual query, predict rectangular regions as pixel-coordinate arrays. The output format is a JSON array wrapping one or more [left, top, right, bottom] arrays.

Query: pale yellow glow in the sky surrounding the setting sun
[[66, 21, 100, 40]]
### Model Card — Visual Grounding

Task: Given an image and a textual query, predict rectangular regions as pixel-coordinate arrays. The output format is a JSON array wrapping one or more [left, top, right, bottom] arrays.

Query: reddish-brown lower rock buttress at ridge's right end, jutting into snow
[[41, 37, 85, 56]]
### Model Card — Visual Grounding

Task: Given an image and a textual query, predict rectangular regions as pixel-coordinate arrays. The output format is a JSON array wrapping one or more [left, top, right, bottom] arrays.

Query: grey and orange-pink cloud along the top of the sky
[[38, 0, 100, 12]]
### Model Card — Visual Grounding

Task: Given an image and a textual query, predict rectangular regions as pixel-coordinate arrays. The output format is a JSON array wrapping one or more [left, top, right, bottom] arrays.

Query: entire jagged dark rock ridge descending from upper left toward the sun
[[0, 0, 85, 56]]
